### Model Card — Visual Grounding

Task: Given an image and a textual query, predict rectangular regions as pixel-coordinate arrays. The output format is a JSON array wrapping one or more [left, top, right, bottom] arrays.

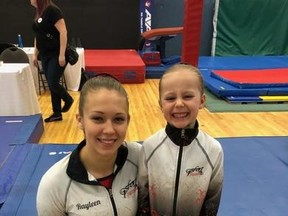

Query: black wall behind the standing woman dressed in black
[[0, 0, 140, 49]]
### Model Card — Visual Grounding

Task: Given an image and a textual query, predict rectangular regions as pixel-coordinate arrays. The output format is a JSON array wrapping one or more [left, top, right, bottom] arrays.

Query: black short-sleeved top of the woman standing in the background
[[32, 5, 63, 58]]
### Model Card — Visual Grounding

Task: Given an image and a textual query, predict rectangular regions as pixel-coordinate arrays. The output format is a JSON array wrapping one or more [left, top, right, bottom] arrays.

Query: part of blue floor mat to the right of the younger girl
[[217, 137, 288, 216]]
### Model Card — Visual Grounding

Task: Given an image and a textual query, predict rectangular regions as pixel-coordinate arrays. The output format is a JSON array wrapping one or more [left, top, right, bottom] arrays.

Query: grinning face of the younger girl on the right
[[160, 70, 205, 128]]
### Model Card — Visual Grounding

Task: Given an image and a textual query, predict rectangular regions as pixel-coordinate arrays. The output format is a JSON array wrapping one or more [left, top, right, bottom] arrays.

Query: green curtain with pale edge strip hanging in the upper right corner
[[212, 0, 288, 56]]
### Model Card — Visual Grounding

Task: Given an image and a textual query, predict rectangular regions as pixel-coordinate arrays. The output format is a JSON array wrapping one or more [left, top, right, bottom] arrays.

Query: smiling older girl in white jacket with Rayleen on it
[[37, 76, 141, 216]]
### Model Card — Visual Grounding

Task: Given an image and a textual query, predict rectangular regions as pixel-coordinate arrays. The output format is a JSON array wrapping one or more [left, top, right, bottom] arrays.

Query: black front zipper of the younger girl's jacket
[[172, 129, 185, 216]]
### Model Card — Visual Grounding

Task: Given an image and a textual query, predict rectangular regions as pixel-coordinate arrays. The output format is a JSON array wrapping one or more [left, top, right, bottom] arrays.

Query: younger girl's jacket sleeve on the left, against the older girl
[[137, 147, 151, 216]]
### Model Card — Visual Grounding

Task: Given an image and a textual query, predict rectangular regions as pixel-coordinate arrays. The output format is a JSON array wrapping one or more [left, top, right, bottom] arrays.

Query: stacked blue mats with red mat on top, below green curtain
[[199, 56, 288, 103]]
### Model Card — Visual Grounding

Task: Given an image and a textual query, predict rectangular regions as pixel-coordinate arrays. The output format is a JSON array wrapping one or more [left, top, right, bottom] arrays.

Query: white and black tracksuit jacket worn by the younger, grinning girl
[[139, 123, 223, 216]]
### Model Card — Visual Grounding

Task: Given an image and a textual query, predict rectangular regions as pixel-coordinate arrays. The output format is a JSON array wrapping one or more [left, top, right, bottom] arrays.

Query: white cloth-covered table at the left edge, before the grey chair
[[0, 63, 40, 116]]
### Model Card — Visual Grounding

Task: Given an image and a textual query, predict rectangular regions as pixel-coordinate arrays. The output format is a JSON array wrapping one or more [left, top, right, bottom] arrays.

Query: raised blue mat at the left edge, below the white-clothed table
[[0, 114, 44, 205]]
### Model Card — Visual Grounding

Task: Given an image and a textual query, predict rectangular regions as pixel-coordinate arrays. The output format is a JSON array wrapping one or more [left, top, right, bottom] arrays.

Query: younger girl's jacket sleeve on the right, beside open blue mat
[[200, 143, 224, 216]]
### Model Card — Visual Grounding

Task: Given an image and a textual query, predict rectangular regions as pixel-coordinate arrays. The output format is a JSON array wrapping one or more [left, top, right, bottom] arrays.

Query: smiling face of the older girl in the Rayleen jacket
[[77, 88, 130, 157]]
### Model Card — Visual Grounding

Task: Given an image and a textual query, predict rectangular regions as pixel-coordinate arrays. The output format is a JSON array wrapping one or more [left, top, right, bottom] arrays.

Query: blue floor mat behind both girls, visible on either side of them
[[0, 137, 288, 216]]
